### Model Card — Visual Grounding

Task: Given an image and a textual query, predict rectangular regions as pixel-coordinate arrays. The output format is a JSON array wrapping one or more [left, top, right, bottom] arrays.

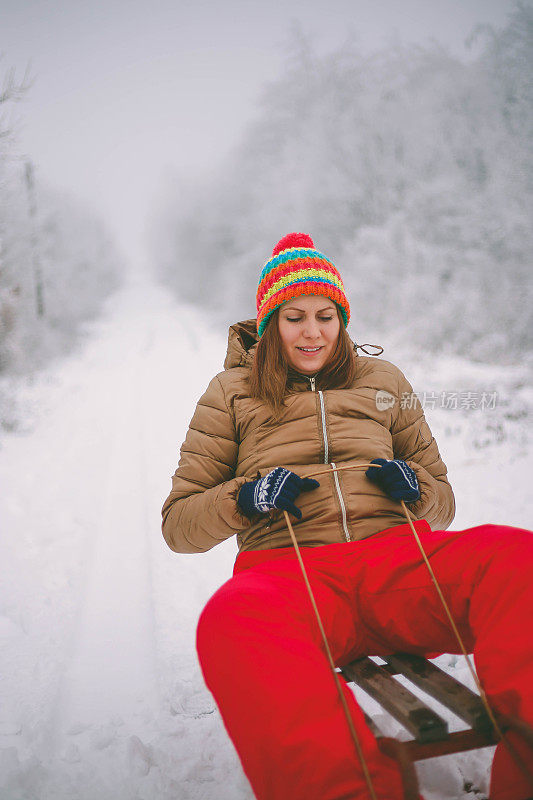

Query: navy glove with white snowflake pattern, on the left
[[237, 467, 320, 519]]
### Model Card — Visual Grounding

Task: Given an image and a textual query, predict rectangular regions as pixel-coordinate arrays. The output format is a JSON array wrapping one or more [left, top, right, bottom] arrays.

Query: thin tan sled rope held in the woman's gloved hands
[[283, 464, 533, 800]]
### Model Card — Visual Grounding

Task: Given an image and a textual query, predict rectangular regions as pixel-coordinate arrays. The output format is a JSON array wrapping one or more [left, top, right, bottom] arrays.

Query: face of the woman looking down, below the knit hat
[[278, 294, 341, 375]]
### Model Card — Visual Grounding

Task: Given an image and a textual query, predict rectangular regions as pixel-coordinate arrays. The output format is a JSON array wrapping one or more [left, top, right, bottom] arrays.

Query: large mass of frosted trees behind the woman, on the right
[[155, 4, 533, 358]]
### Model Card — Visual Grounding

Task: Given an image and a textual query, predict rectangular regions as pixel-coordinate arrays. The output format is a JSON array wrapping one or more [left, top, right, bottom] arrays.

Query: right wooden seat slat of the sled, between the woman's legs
[[386, 653, 492, 734]]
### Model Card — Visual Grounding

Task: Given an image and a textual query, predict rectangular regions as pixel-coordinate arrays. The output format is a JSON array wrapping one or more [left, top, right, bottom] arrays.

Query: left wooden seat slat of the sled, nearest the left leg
[[342, 657, 448, 742]]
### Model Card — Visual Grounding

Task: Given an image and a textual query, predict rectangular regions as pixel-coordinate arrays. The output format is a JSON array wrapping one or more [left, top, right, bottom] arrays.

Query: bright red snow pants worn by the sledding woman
[[197, 521, 533, 800]]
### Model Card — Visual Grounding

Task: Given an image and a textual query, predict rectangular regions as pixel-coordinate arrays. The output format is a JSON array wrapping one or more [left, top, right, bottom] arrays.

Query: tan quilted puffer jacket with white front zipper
[[163, 320, 455, 553]]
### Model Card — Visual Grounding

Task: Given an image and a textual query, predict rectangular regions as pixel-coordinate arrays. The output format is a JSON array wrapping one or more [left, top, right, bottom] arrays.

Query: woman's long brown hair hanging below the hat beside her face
[[250, 308, 356, 415]]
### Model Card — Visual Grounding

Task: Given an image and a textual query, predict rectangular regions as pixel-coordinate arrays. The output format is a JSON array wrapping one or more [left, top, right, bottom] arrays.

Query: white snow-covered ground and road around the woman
[[0, 280, 533, 800]]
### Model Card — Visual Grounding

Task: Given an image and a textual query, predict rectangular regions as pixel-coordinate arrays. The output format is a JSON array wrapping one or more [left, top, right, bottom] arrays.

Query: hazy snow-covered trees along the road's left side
[[0, 67, 122, 372]]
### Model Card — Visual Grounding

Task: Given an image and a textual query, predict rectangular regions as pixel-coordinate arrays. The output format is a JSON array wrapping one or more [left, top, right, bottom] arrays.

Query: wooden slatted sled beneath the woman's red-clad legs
[[341, 654, 533, 800]]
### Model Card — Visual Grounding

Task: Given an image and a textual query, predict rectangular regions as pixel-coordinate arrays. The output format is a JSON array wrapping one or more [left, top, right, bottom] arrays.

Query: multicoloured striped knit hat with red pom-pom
[[257, 233, 350, 337]]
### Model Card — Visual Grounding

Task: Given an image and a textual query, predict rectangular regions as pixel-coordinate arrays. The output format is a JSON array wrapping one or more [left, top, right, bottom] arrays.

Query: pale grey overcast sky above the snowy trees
[[0, 0, 514, 268]]
